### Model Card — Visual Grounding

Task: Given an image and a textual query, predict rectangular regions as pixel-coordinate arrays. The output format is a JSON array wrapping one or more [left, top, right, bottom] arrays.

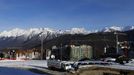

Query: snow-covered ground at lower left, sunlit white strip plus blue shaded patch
[[0, 60, 47, 75]]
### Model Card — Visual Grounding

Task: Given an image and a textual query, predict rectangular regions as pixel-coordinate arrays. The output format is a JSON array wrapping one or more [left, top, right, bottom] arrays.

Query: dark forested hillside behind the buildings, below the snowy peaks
[[31, 32, 127, 57]]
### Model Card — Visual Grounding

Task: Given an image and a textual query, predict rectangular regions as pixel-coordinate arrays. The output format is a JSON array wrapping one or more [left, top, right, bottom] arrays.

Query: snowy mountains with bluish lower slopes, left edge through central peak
[[0, 28, 89, 48]]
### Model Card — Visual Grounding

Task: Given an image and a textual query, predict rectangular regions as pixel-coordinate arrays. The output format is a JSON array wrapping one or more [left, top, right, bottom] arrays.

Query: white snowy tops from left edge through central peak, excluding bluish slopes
[[0, 28, 89, 38]]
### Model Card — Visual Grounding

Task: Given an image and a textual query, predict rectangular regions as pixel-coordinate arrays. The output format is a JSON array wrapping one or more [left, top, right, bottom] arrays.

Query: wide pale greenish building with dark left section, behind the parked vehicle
[[51, 45, 93, 60]]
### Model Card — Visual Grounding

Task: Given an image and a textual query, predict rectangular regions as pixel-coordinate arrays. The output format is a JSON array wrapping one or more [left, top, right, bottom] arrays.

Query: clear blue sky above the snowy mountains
[[0, 0, 134, 31]]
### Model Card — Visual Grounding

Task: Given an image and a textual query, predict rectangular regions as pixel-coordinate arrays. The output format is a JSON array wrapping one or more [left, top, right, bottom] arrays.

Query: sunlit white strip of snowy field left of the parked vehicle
[[0, 60, 47, 68]]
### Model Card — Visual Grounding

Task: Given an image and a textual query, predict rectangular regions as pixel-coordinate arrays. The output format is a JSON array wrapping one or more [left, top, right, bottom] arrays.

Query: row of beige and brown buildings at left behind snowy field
[[2, 48, 40, 60]]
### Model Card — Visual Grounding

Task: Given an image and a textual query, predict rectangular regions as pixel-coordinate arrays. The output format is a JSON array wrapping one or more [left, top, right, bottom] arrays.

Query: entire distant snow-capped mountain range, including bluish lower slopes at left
[[0, 26, 134, 49]]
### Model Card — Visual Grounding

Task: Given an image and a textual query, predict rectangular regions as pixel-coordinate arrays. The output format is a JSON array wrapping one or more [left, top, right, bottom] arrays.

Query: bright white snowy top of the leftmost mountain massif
[[0, 28, 53, 37]]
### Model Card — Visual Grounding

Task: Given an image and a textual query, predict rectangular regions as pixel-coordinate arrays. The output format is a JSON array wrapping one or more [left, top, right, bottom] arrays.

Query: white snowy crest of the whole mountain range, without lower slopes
[[0, 26, 134, 39]]
